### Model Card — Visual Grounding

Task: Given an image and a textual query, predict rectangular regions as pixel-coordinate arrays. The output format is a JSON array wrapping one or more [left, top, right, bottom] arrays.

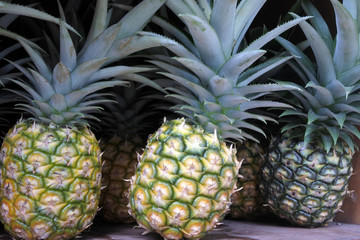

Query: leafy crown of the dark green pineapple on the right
[[277, 0, 360, 151]]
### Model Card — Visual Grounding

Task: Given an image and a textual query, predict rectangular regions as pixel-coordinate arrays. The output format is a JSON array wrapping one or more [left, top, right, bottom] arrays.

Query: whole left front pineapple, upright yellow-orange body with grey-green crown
[[0, 0, 163, 239]]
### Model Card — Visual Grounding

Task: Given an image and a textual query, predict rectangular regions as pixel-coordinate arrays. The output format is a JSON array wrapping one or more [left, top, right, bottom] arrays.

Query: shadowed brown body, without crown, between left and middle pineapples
[[100, 136, 144, 223]]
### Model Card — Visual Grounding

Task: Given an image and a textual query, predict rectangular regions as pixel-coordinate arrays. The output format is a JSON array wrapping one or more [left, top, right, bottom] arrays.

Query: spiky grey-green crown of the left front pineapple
[[0, 0, 164, 126]]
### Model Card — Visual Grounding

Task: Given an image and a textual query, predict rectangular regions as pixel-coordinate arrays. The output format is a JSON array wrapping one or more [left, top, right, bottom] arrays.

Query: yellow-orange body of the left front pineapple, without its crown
[[0, 120, 101, 240]]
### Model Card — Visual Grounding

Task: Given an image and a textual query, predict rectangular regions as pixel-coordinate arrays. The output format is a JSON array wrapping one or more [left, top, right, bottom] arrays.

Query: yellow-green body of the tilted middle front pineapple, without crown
[[130, 119, 240, 239]]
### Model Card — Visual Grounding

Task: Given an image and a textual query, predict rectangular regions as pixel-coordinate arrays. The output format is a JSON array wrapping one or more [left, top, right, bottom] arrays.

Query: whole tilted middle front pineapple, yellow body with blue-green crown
[[130, 0, 307, 239]]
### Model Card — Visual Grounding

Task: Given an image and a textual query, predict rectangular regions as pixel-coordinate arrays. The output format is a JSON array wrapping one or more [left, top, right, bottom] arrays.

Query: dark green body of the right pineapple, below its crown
[[260, 131, 353, 227]]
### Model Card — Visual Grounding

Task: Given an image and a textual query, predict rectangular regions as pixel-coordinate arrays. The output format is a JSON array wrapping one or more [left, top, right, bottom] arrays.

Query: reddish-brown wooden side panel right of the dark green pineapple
[[335, 141, 360, 224]]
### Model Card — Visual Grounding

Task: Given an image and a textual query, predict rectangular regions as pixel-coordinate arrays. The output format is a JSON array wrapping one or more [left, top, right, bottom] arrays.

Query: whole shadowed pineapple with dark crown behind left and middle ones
[[100, 83, 165, 223]]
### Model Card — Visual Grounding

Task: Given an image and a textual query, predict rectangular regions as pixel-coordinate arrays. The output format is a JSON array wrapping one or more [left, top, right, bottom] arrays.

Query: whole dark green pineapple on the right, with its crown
[[260, 0, 360, 227]]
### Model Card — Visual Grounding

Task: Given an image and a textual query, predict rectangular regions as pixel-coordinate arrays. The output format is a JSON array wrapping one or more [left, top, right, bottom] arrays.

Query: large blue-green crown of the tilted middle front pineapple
[[136, 0, 308, 141]]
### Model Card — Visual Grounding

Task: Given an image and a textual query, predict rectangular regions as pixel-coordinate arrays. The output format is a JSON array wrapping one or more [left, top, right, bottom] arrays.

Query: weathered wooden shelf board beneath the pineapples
[[0, 220, 360, 240]]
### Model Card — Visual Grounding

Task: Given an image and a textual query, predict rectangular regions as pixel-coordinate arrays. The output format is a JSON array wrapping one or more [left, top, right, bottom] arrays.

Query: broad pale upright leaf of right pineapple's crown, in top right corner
[[331, 0, 359, 73]]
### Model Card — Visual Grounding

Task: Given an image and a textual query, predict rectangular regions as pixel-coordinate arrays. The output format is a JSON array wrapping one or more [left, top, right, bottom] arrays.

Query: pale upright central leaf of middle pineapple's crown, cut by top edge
[[210, 0, 237, 59]]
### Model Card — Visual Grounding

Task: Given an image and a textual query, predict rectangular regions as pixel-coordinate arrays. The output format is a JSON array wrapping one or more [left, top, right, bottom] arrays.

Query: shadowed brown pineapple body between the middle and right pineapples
[[229, 140, 268, 220]]
